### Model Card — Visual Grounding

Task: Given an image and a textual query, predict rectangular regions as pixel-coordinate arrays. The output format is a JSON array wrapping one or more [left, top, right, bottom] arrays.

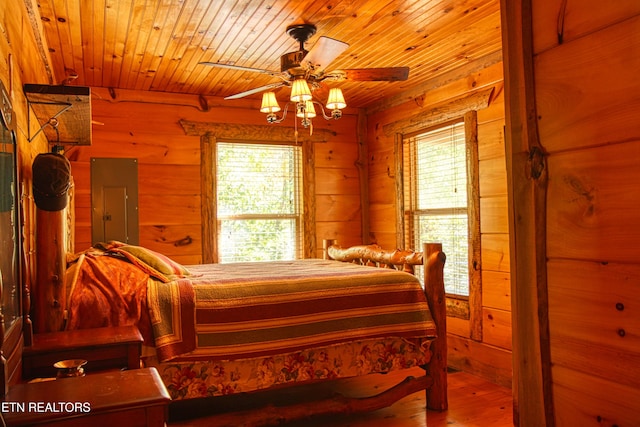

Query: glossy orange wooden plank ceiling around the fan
[[38, 0, 501, 107]]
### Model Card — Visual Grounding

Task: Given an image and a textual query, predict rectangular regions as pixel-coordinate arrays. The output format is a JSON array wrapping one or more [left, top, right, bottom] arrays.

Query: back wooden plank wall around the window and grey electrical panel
[[67, 88, 362, 264]]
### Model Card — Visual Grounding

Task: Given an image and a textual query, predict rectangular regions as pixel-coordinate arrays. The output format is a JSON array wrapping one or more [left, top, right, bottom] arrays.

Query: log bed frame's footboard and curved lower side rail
[[0, 240, 448, 426]]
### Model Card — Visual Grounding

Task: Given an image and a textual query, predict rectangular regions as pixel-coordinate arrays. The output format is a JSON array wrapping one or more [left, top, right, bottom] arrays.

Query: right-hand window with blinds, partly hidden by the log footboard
[[403, 122, 469, 297]]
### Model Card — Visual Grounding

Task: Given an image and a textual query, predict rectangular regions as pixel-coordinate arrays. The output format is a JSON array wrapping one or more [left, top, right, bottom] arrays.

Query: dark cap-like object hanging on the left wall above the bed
[[32, 153, 71, 211]]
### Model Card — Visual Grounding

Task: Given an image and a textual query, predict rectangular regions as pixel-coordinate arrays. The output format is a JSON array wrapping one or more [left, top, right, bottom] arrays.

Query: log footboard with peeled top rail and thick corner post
[[323, 240, 448, 411]]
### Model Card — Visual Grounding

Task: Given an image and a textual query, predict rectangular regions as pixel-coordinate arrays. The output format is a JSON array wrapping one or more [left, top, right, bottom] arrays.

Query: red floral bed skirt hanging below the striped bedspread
[[145, 338, 431, 400]]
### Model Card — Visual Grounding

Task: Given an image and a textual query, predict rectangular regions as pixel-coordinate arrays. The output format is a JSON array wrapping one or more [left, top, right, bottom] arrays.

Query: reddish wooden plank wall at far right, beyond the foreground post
[[520, 0, 640, 426]]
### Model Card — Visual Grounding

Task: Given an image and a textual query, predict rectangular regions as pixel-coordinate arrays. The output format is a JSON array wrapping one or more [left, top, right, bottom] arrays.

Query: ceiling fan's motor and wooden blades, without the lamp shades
[[200, 23, 409, 99]]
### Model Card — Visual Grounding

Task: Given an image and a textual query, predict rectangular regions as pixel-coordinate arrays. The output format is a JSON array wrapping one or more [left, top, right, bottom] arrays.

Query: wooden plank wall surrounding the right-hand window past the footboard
[[367, 62, 511, 386]]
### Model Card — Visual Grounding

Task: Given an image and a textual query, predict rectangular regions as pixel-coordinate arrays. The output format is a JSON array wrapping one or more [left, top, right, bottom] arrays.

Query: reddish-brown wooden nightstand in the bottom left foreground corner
[[0, 368, 171, 427]]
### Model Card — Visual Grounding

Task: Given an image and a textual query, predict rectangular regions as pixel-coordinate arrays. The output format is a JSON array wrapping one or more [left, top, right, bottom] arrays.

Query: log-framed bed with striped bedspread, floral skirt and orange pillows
[[36, 241, 447, 424]]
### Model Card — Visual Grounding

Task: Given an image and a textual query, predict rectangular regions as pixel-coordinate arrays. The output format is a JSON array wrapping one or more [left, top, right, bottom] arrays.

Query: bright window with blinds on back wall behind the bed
[[216, 143, 302, 263]]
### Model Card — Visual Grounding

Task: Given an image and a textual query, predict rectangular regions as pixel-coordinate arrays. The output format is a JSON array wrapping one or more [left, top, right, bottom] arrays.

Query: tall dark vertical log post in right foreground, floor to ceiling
[[500, 0, 556, 427]]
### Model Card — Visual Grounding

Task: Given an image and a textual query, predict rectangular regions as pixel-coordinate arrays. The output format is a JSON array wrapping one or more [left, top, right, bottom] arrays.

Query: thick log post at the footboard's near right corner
[[423, 243, 449, 411]]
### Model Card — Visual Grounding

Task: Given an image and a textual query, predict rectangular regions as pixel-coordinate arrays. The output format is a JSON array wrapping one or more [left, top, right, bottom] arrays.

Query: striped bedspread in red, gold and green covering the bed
[[147, 259, 435, 362]]
